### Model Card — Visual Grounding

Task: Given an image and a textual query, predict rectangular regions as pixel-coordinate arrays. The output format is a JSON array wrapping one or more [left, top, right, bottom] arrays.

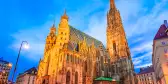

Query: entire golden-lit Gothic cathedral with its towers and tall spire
[[36, 0, 134, 84]]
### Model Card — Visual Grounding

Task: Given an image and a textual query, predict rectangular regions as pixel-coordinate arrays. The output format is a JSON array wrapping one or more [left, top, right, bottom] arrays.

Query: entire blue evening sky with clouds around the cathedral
[[0, 0, 168, 79]]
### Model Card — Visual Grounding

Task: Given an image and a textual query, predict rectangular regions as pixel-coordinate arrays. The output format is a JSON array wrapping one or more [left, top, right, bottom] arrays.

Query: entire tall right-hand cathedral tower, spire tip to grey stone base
[[106, 0, 135, 84]]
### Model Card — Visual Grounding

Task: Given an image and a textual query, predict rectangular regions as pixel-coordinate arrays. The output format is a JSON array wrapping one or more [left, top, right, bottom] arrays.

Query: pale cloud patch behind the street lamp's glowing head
[[9, 22, 52, 61]]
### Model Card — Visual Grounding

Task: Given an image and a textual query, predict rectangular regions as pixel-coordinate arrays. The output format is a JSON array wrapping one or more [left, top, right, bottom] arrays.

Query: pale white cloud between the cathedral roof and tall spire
[[84, 12, 106, 45]]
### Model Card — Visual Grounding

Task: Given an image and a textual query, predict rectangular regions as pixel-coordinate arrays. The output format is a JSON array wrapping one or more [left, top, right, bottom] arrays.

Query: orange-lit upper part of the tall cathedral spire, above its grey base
[[106, 0, 130, 62]]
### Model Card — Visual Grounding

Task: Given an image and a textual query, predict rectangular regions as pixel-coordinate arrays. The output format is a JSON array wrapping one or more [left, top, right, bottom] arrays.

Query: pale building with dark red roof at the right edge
[[152, 20, 168, 84]]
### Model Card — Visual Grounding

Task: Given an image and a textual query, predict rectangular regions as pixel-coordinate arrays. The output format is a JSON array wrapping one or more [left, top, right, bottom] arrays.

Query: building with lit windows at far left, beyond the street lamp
[[0, 58, 12, 84]]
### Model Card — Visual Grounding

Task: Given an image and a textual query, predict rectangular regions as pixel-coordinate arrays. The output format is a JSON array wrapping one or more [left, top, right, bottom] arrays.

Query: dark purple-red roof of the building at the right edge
[[154, 24, 168, 40]]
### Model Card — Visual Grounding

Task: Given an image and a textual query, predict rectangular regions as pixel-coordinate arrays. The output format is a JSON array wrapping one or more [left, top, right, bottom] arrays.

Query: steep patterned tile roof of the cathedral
[[69, 26, 104, 48]]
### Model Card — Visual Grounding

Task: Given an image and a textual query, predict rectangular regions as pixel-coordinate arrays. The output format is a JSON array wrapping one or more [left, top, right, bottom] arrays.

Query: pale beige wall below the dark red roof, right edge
[[152, 38, 168, 84]]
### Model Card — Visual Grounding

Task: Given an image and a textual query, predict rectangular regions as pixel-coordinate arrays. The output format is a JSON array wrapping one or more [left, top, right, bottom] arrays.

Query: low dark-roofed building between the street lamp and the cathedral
[[15, 67, 37, 84]]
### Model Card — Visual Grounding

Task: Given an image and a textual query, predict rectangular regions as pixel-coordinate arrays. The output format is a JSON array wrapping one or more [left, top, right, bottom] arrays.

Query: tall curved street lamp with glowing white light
[[12, 41, 29, 82]]
